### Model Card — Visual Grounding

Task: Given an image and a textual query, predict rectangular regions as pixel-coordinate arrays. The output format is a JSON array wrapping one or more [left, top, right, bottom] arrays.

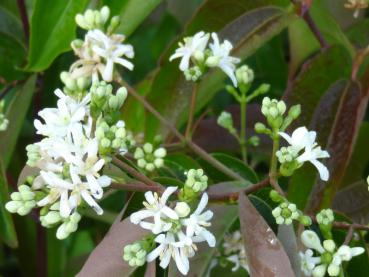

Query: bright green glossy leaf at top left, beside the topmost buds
[[26, 0, 88, 72]]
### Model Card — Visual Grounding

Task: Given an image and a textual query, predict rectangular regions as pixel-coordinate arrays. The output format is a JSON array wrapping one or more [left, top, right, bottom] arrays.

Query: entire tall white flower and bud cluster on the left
[[6, 7, 133, 239]]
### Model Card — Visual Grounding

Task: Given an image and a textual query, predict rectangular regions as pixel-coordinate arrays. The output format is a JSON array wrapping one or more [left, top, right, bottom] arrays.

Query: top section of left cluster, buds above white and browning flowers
[[70, 7, 134, 82]]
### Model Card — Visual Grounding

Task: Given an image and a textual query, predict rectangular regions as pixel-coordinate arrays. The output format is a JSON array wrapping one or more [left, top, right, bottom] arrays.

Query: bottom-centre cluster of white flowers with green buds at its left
[[123, 187, 216, 275]]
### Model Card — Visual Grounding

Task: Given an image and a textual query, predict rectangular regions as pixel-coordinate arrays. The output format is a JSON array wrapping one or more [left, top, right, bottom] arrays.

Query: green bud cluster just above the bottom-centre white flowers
[[179, 168, 209, 202]]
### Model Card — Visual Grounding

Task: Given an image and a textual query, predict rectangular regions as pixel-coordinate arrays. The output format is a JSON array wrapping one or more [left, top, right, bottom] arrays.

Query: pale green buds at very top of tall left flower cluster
[[75, 6, 119, 32]]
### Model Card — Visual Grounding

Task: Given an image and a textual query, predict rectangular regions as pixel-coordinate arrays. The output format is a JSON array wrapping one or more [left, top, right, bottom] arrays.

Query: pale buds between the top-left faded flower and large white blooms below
[[60, 71, 91, 99]]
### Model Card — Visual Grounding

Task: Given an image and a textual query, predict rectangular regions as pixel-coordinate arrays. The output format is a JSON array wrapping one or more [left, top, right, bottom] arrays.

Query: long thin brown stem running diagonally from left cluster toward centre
[[115, 77, 246, 181]]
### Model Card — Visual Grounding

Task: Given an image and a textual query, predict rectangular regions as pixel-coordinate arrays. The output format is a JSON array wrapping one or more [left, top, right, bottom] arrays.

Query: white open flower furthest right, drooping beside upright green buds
[[279, 127, 329, 181]]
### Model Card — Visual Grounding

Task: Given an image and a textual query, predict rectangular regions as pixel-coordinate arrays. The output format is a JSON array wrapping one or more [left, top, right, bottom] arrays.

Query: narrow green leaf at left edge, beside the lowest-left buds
[[0, 162, 18, 248]]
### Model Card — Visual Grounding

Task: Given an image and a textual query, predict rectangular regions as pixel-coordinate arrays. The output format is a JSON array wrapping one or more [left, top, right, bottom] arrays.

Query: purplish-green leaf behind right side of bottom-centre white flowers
[[168, 204, 237, 277]]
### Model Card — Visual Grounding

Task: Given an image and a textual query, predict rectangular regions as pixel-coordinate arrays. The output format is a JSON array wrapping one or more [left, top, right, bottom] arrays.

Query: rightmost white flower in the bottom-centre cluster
[[183, 193, 216, 247]]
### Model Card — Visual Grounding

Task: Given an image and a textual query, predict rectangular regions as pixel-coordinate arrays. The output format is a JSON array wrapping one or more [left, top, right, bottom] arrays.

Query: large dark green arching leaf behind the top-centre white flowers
[[146, 0, 295, 138]]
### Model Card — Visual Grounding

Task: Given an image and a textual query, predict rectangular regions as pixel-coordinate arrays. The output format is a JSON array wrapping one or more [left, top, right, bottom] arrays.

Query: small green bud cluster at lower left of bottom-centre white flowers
[[123, 236, 154, 267]]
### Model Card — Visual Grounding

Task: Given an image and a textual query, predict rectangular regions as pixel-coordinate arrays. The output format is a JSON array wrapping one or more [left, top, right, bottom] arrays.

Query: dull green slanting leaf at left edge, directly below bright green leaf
[[0, 75, 36, 169]]
